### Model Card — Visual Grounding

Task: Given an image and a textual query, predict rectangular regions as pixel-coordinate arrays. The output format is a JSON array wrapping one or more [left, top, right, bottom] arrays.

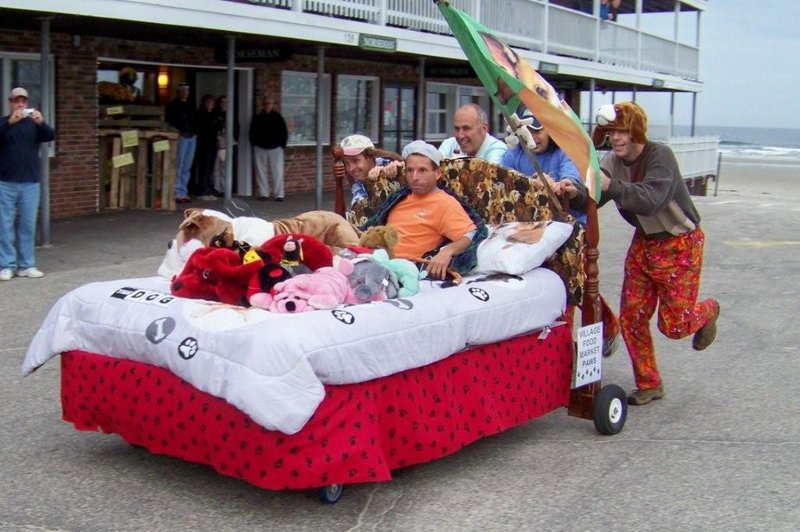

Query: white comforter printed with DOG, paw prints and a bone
[[22, 268, 565, 434]]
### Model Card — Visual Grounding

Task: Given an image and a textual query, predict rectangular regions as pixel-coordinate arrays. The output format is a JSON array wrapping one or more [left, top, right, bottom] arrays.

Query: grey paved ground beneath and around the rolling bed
[[0, 163, 800, 532]]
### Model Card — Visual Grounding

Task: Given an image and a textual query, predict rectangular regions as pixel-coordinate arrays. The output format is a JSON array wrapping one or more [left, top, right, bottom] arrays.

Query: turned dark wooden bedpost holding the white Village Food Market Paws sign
[[567, 198, 602, 419]]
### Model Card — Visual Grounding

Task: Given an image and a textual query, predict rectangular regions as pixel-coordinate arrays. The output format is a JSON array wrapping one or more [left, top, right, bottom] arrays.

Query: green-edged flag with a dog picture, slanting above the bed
[[434, 0, 600, 201]]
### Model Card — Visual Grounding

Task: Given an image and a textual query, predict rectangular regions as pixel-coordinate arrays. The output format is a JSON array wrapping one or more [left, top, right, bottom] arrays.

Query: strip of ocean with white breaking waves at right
[[648, 124, 800, 165]]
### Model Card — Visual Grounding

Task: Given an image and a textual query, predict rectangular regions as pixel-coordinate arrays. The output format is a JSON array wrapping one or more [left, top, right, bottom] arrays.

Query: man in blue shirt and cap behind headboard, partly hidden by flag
[[501, 108, 587, 225]]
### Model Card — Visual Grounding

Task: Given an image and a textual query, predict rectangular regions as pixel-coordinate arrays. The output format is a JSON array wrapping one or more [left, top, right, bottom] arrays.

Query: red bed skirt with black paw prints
[[61, 326, 572, 490]]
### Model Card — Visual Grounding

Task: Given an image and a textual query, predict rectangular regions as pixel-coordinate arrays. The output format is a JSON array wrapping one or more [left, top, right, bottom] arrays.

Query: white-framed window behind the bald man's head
[[425, 83, 493, 140]]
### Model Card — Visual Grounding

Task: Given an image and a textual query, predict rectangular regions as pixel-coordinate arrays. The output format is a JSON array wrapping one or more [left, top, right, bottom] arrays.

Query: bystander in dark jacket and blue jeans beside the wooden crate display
[[165, 83, 197, 203]]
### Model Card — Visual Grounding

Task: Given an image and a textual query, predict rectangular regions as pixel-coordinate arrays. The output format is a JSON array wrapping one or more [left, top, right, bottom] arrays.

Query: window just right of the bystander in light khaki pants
[[280, 71, 331, 146]]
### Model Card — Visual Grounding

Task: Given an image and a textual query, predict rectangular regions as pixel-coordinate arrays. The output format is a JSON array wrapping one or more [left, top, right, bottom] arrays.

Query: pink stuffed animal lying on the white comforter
[[269, 259, 357, 313]]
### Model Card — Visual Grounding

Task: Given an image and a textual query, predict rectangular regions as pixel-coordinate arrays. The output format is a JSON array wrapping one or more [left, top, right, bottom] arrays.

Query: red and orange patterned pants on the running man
[[619, 228, 716, 390]]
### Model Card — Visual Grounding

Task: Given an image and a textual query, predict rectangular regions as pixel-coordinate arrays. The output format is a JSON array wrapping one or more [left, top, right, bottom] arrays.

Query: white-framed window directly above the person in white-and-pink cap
[[336, 75, 380, 141]]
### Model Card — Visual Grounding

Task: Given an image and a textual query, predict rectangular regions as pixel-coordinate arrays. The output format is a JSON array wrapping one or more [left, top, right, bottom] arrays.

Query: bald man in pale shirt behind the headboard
[[439, 103, 508, 164]]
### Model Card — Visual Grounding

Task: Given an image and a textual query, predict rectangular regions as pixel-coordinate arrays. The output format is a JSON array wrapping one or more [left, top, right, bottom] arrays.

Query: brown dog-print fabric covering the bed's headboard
[[347, 157, 586, 305]]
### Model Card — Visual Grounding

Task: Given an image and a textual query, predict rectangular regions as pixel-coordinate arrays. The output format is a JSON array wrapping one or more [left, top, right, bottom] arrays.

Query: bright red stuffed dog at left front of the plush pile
[[170, 247, 262, 306]]
